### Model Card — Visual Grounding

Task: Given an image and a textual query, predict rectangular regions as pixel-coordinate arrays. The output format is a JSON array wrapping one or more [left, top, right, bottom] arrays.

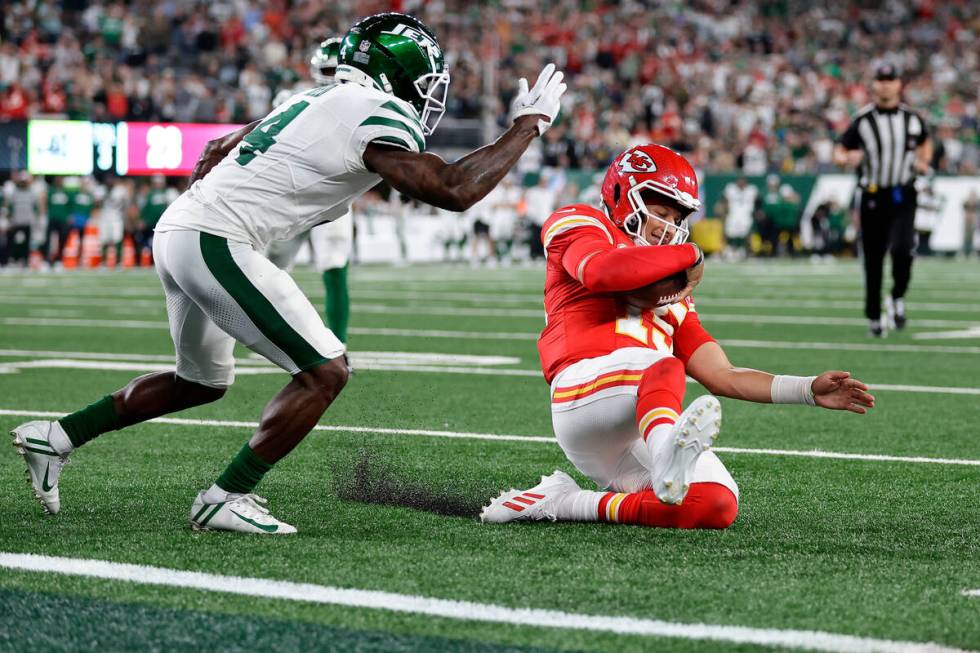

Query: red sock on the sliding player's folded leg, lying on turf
[[599, 483, 738, 528]]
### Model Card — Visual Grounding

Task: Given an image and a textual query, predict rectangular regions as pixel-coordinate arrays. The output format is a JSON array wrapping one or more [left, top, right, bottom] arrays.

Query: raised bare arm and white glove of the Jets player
[[363, 64, 566, 211]]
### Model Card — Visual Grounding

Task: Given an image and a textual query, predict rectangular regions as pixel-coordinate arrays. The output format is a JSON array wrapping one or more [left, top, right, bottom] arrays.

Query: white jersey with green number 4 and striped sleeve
[[156, 83, 425, 251]]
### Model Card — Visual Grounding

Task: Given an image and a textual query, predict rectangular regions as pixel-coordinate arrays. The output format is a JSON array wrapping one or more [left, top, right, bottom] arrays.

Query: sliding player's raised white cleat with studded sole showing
[[650, 395, 721, 503]]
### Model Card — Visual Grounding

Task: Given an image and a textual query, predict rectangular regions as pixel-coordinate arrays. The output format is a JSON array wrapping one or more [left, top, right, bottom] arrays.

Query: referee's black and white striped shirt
[[840, 104, 929, 193]]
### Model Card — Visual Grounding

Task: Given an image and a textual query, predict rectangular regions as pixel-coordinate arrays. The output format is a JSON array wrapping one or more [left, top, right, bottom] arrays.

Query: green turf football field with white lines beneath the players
[[0, 260, 980, 652]]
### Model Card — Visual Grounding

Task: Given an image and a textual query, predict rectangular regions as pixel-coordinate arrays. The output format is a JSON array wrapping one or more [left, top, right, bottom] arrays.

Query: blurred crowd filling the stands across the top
[[0, 0, 980, 175]]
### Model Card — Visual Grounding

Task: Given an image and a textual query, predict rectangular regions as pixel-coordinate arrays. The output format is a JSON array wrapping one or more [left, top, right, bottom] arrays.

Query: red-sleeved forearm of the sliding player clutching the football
[[580, 243, 700, 292]]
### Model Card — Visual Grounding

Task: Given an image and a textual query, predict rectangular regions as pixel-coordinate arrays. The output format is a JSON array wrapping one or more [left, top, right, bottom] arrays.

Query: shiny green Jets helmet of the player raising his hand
[[336, 12, 449, 134]]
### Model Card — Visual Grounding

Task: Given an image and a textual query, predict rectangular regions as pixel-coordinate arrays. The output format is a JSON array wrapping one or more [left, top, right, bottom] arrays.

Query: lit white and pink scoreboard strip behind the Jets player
[[17, 120, 241, 176]]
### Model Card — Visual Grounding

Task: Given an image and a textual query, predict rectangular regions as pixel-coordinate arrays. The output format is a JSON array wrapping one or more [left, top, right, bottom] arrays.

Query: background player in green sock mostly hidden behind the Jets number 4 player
[[266, 38, 354, 343]]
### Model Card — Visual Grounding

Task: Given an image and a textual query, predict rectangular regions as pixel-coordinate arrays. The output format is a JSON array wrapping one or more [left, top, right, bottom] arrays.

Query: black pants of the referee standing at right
[[861, 186, 916, 320]]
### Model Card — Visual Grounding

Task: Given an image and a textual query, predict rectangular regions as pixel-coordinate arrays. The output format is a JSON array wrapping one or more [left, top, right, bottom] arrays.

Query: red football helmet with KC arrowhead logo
[[602, 143, 701, 245]]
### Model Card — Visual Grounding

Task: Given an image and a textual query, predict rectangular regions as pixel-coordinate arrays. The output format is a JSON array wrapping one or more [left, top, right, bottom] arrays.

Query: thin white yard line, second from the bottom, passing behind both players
[[0, 408, 980, 467]]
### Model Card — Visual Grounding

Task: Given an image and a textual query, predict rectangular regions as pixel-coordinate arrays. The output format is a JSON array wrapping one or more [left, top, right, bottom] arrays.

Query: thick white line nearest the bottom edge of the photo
[[0, 553, 962, 653]]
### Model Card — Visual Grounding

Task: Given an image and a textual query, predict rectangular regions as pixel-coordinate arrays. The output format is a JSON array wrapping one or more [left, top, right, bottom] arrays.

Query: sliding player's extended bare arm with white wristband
[[686, 341, 875, 415]]
